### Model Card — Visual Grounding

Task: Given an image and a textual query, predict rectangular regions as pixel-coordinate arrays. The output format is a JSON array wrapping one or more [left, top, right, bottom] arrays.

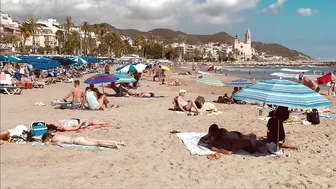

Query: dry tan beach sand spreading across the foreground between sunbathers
[[1, 65, 336, 188]]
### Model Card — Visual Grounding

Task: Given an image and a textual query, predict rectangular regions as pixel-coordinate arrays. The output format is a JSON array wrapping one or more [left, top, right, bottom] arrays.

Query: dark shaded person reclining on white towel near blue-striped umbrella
[[200, 124, 268, 155]]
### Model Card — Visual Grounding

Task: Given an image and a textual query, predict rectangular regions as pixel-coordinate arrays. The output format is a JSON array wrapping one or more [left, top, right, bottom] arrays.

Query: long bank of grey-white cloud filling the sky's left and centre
[[1, 0, 260, 30]]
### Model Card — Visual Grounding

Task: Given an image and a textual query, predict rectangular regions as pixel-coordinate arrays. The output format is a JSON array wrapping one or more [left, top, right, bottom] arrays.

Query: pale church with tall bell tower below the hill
[[233, 29, 254, 61]]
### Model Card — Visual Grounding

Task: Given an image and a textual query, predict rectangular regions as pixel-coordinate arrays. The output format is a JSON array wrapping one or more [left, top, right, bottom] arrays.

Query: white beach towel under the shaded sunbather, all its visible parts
[[176, 132, 271, 157]]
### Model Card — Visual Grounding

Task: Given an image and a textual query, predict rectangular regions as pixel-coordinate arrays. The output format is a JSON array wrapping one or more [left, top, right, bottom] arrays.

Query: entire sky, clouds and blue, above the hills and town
[[1, 0, 336, 60]]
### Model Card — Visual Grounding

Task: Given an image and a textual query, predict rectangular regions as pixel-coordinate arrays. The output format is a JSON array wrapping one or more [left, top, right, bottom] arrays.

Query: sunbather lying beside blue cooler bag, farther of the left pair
[[47, 118, 110, 131]]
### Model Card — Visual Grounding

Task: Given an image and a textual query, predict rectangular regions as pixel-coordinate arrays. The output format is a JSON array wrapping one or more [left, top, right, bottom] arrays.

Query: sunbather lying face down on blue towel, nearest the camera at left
[[42, 133, 126, 149]]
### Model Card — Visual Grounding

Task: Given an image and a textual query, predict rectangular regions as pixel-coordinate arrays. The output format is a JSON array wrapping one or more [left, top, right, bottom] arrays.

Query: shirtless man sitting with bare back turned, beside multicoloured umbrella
[[63, 80, 85, 109]]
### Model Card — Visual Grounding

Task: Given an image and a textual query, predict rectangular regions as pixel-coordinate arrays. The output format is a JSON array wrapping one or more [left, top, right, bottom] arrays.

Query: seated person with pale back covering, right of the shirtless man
[[85, 88, 109, 110]]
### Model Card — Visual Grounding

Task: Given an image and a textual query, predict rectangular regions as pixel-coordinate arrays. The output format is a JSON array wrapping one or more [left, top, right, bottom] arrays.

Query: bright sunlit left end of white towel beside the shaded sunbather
[[176, 133, 215, 156]]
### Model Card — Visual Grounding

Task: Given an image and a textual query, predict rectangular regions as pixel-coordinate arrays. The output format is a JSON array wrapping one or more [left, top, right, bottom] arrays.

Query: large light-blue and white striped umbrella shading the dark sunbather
[[233, 79, 332, 109]]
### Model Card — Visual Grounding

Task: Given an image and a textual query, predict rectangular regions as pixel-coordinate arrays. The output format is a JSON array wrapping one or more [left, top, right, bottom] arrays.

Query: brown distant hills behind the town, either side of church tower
[[107, 24, 310, 59]]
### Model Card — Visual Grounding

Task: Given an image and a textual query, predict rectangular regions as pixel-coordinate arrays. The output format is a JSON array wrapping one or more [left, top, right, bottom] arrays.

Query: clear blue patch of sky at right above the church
[[202, 0, 336, 60]]
